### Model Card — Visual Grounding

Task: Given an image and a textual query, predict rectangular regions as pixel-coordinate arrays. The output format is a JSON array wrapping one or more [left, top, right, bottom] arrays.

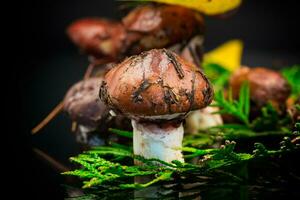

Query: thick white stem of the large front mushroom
[[131, 120, 184, 164]]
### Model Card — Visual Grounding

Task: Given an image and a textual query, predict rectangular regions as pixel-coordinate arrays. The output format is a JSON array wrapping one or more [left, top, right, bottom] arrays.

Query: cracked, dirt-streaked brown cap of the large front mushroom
[[99, 49, 213, 120]]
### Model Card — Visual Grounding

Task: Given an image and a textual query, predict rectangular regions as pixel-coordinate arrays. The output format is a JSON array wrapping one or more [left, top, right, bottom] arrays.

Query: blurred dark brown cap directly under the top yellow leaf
[[122, 5, 204, 53]]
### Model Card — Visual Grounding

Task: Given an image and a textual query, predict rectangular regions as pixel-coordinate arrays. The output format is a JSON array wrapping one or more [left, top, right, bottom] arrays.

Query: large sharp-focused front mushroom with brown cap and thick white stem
[[99, 49, 213, 162]]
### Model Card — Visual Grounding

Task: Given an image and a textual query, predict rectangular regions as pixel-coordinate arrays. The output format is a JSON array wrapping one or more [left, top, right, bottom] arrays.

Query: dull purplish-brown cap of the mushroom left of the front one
[[64, 77, 109, 127]]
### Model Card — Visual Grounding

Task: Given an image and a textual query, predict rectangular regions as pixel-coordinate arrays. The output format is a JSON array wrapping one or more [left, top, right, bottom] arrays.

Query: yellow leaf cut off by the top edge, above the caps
[[146, 0, 242, 15]]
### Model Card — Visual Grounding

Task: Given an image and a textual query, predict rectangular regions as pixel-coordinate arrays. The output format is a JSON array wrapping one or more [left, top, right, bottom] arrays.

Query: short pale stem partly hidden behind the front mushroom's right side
[[185, 107, 223, 134]]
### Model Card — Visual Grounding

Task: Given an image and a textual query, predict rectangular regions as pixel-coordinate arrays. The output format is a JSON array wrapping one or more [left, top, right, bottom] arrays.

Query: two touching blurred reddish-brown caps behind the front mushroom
[[67, 4, 204, 67]]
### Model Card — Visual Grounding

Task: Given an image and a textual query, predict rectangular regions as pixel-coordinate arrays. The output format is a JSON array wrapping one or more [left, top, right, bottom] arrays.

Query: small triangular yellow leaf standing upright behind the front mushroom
[[204, 40, 243, 71]]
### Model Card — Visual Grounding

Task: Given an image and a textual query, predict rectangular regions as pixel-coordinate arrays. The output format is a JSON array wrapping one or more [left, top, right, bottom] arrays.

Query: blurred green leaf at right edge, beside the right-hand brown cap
[[281, 65, 300, 97]]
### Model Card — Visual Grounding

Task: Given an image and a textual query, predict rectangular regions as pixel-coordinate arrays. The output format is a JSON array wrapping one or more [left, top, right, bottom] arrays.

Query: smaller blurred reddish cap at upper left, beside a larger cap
[[67, 18, 126, 59]]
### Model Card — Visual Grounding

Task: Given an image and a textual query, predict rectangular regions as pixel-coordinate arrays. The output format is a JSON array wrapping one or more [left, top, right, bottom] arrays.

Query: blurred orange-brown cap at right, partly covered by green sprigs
[[230, 67, 291, 106]]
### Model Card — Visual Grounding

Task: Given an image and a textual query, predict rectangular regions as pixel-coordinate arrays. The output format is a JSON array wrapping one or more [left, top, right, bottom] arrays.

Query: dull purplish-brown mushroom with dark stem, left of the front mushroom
[[63, 77, 126, 147]]
